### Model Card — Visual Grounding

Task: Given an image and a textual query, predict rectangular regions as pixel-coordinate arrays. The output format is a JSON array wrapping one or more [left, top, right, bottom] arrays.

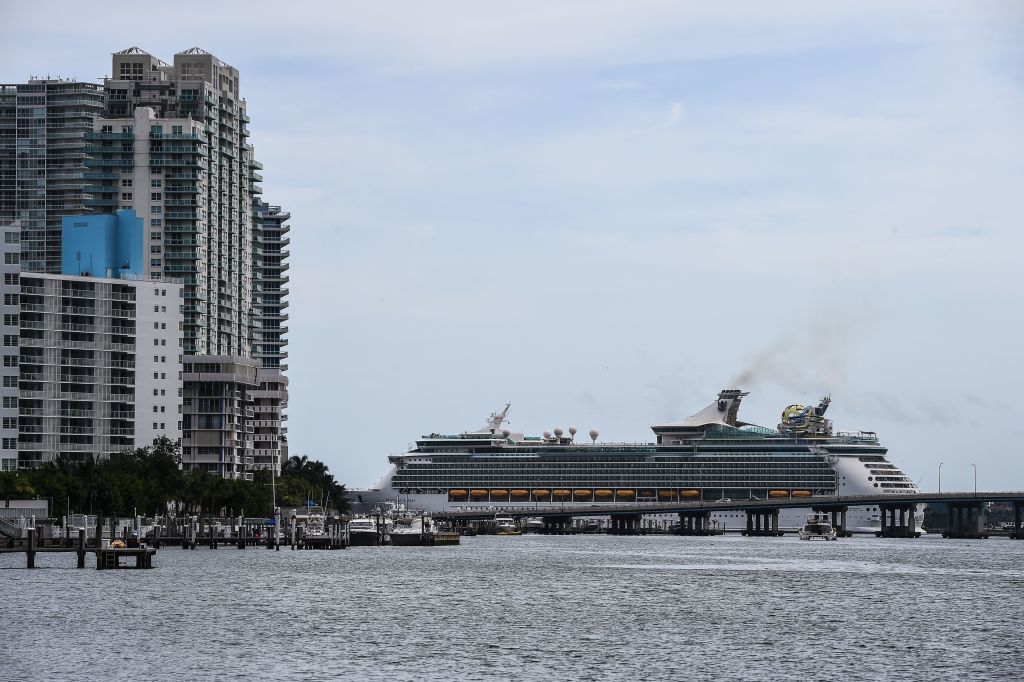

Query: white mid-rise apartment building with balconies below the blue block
[[17, 272, 183, 468]]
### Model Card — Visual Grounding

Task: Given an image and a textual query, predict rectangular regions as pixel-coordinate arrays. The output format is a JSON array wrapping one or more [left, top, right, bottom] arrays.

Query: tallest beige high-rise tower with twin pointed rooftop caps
[[87, 47, 259, 355]]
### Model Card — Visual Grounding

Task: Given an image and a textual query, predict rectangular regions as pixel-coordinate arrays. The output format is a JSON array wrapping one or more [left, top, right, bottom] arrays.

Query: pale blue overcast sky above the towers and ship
[[6, 0, 1024, 489]]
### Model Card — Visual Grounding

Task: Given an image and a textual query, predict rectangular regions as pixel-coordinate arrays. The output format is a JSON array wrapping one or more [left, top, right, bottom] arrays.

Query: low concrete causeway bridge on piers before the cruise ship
[[433, 492, 1024, 539]]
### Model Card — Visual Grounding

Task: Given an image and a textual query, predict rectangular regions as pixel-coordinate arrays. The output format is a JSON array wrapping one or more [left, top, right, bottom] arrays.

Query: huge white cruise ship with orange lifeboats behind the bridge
[[352, 389, 924, 532]]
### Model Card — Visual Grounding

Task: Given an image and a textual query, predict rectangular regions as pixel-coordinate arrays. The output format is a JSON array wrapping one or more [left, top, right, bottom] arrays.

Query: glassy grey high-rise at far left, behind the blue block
[[0, 79, 103, 272]]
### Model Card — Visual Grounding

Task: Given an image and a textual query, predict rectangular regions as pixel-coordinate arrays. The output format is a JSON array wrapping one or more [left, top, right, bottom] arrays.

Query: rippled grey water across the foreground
[[0, 536, 1024, 680]]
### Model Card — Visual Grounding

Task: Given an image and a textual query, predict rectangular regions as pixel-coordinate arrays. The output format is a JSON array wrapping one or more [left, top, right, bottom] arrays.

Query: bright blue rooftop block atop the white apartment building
[[60, 209, 144, 279]]
